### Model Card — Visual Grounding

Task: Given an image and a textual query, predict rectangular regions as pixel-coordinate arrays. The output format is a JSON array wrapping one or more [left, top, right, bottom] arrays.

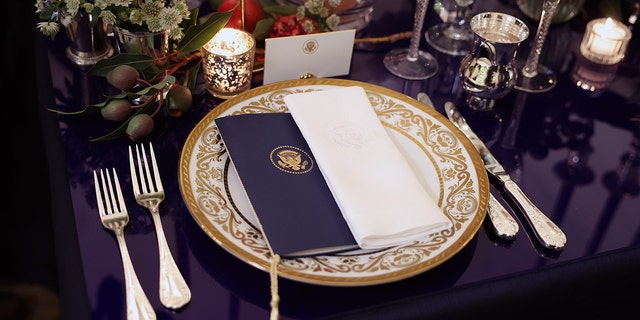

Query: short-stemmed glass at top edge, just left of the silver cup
[[424, 0, 474, 56]]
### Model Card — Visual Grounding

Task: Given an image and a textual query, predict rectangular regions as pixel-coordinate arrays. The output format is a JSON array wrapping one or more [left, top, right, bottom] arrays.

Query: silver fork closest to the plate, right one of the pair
[[129, 143, 191, 309]]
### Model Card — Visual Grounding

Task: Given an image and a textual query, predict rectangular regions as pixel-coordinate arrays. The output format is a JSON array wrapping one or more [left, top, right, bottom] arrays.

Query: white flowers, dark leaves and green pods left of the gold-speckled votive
[[35, 0, 231, 140]]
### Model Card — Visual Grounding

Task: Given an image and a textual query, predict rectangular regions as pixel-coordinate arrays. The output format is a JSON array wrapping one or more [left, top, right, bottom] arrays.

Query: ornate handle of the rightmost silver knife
[[504, 179, 567, 251]]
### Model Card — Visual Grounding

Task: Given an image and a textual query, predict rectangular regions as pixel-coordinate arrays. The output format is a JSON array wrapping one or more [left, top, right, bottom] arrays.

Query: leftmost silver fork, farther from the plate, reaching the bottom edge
[[93, 168, 156, 320]]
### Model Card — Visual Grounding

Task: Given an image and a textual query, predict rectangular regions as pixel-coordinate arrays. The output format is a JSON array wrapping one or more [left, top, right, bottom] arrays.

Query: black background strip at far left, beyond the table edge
[[0, 0, 60, 320]]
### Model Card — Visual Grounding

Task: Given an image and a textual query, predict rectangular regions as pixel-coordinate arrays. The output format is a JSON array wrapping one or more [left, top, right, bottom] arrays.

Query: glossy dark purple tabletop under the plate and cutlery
[[43, 1, 640, 319]]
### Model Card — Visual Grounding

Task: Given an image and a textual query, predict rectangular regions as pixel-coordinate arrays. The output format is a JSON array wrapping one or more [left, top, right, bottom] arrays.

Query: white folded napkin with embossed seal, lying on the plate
[[284, 86, 452, 249]]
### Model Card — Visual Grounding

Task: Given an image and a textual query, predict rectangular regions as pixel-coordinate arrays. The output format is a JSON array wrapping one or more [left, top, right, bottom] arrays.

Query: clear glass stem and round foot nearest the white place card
[[383, 0, 438, 80]]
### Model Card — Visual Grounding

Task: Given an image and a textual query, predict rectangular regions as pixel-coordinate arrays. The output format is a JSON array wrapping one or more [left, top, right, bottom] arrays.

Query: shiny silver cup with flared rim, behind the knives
[[459, 12, 529, 110]]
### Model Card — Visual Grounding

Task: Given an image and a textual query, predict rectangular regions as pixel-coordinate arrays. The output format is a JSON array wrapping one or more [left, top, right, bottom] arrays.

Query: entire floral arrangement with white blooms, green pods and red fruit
[[35, 0, 370, 141]]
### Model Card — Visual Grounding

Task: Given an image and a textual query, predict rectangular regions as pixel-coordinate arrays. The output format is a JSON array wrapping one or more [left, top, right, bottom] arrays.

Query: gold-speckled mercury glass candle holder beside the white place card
[[201, 28, 256, 99]]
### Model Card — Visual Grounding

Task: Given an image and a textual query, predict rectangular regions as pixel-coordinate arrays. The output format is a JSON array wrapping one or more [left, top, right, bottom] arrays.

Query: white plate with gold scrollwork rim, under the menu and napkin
[[178, 78, 489, 286]]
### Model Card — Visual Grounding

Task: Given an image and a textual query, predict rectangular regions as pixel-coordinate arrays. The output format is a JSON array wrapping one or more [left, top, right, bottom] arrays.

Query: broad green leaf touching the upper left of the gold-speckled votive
[[178, 12, 231, 52]]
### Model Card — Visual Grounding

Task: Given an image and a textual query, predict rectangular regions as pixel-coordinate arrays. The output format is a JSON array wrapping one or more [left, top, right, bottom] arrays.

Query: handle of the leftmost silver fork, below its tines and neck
[[116, 232, 156, 320]]
